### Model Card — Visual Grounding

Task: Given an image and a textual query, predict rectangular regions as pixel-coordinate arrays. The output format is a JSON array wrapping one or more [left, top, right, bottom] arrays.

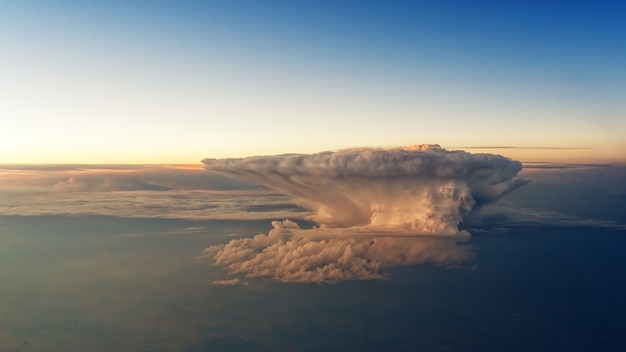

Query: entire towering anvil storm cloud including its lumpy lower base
[[202, 145, 524, 282]]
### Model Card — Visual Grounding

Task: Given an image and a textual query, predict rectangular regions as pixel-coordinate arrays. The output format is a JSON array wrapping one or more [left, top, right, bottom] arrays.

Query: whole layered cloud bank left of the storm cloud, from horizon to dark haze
[[0, 165, 307, 219]]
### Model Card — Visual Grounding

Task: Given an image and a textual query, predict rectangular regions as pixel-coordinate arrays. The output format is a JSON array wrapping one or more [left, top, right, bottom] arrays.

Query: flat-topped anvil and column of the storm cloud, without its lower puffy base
[[203, 145, 522, 234]]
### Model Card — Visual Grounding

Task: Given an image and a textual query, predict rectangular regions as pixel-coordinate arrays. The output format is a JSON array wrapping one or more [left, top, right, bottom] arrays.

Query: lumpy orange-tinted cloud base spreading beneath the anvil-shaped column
[[204, 220, 474, 284]]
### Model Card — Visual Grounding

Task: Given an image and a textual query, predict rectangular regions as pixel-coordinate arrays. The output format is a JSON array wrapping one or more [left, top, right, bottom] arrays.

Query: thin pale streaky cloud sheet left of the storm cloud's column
[[0, 190, 310, 220]]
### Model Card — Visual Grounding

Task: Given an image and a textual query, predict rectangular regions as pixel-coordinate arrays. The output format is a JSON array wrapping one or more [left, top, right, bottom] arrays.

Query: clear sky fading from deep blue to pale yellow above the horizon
[[0, 1, 626, 163]]
